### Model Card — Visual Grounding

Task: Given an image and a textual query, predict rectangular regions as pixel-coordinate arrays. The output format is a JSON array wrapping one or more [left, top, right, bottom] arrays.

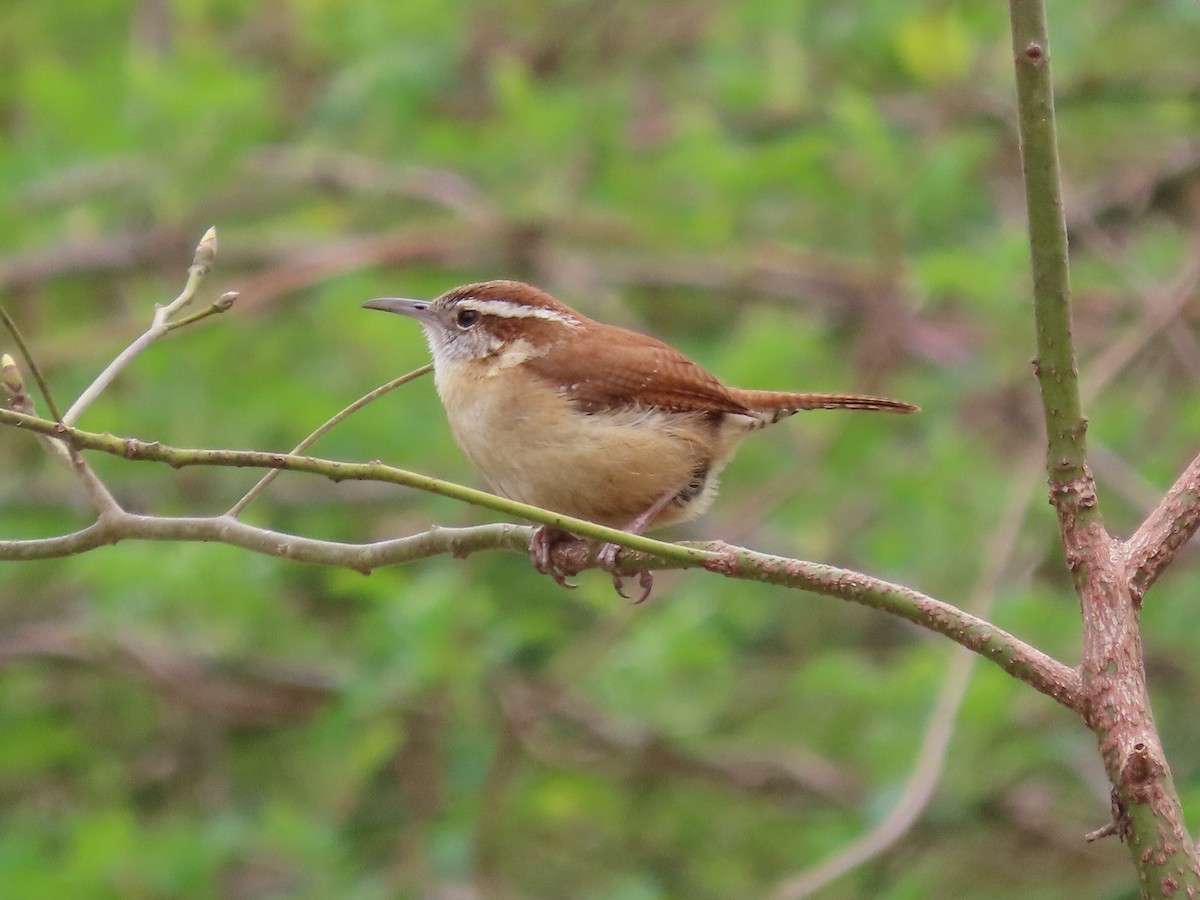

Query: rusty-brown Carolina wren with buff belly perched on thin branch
[[364, 281, 917, 599]]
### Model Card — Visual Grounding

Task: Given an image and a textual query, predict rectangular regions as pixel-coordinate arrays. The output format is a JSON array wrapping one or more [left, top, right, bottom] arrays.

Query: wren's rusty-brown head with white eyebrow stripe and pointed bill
[[362, 281, 584, 366]]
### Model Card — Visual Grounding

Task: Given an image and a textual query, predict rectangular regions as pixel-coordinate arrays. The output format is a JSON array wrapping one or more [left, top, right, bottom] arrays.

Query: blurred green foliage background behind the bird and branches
[[0, 0, 1200, 900]]
